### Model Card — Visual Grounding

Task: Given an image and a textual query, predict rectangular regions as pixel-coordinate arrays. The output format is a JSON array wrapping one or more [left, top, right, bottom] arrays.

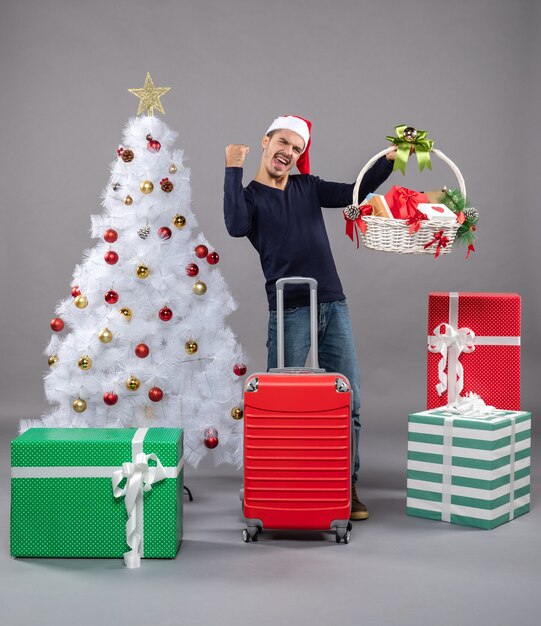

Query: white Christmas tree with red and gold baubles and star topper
[[21, 74, 246, 466]]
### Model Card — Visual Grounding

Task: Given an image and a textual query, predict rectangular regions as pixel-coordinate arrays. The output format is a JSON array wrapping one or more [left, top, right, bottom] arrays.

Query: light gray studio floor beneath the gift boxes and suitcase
[[0, 426, 541, 626]]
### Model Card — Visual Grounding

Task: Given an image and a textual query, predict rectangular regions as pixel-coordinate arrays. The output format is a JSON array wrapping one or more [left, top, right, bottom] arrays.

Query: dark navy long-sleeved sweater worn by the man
[[224, 157, 393, 310]]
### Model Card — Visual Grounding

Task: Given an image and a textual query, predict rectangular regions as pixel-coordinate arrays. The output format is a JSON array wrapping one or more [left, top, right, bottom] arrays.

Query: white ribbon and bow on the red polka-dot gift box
[[428, 291, 520, 403]]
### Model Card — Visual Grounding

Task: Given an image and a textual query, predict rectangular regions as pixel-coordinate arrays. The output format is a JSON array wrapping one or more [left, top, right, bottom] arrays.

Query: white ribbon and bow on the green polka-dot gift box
[[11, 428, 184, 569]]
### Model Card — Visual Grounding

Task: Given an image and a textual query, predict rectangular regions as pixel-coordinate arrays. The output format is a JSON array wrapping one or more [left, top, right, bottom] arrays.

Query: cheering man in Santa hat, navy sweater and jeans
[[224, 115, 395, 520]]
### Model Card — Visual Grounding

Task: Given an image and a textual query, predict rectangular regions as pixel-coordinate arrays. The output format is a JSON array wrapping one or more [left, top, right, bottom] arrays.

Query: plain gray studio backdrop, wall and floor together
[[0, 0, 541, 624]]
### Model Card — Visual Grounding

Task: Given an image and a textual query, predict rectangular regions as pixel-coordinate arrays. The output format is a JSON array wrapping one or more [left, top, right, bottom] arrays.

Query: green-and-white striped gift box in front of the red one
[[406, 407, 531, 529]]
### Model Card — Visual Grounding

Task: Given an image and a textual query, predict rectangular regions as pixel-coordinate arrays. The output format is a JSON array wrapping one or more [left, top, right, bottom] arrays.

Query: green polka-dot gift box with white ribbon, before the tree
[[11, 428, 184, 568]]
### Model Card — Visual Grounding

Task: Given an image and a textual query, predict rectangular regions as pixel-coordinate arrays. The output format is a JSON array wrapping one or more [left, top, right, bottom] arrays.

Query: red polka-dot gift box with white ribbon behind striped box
[[427, 292, 520, 411]]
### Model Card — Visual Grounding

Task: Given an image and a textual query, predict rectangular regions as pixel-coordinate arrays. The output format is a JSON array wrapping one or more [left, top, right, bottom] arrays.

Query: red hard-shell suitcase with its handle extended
[[241, 277, 351, 543]]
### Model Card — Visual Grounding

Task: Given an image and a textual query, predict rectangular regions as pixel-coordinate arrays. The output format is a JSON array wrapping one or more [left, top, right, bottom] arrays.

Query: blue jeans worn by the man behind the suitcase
[[267, 300, 361, 483]]
